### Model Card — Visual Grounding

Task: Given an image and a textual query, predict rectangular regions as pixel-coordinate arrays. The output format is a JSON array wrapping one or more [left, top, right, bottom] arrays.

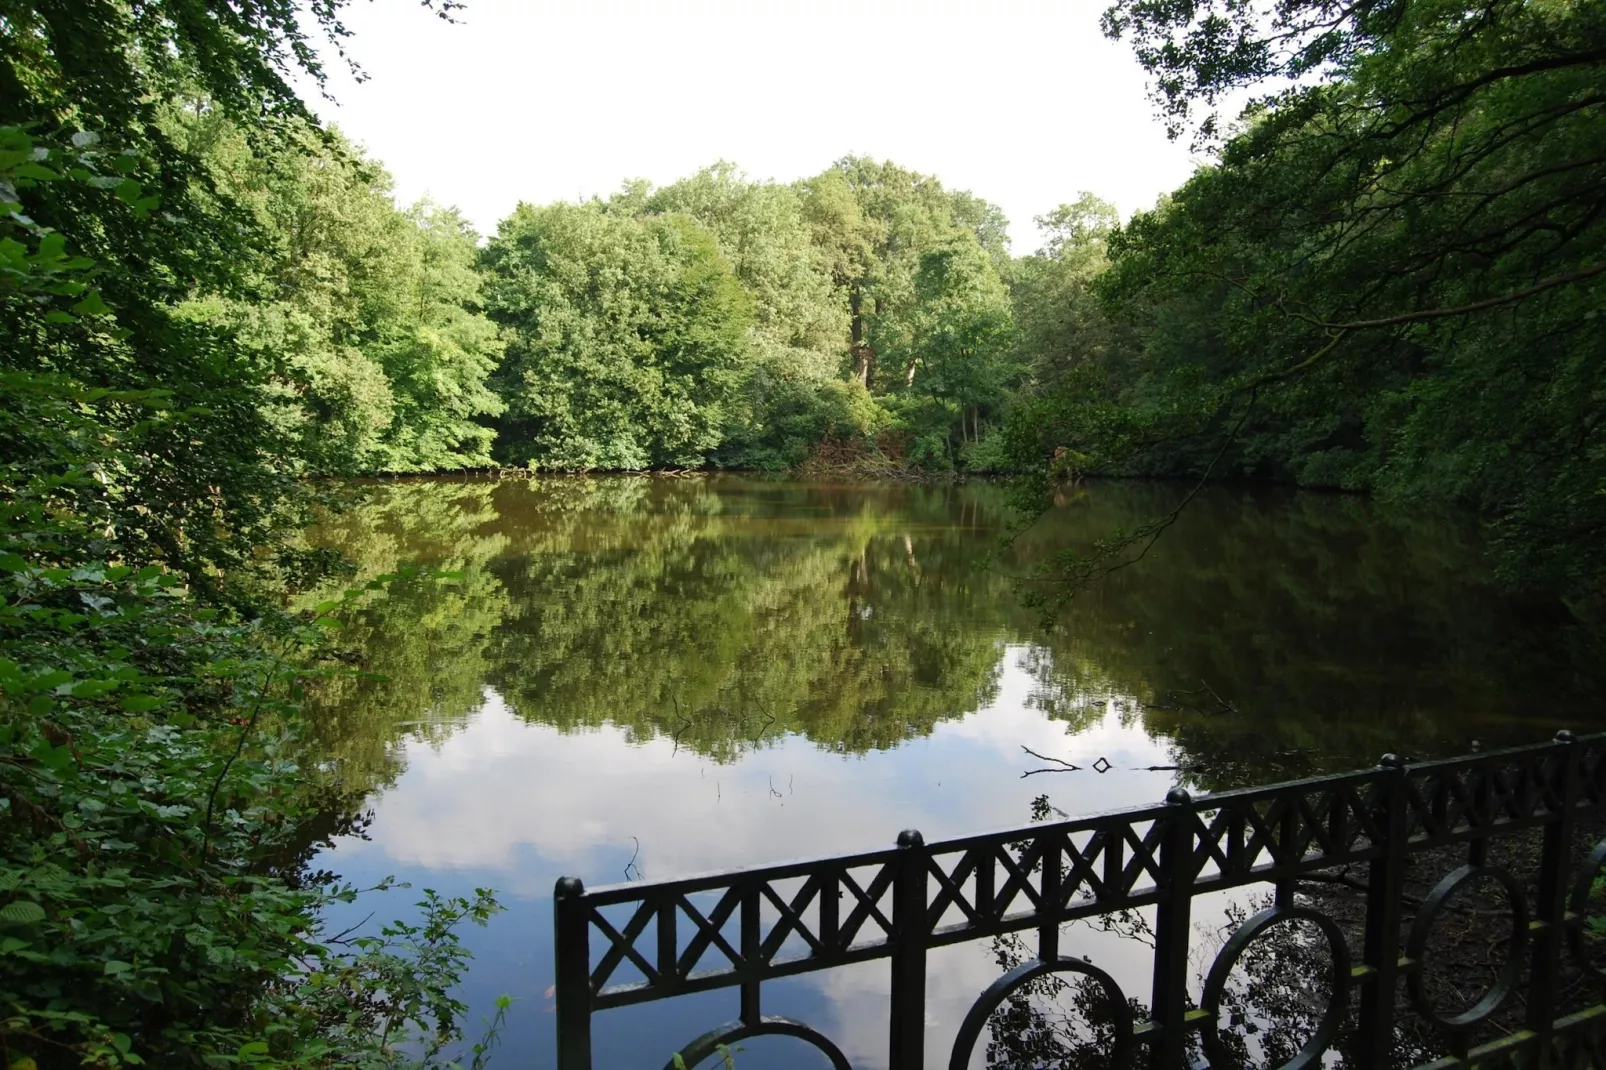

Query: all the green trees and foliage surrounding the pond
[[0, 0, 1606, 1070]]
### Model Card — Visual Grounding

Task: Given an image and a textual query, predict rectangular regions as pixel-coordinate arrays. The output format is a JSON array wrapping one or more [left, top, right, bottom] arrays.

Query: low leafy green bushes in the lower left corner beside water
[[0, 554, 498, 1067]]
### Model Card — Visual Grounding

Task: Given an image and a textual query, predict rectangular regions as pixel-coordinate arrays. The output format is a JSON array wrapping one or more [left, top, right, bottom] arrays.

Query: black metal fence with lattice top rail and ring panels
[[556, 733, 1606, 1070]]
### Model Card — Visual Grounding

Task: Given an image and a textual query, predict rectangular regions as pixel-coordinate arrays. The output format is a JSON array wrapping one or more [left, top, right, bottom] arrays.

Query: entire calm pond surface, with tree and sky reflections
[[303, 477, 1606, 1070]]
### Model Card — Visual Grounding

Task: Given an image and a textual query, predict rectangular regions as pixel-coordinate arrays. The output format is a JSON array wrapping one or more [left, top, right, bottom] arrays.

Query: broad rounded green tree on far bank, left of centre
[[485, 204, 752, 469]]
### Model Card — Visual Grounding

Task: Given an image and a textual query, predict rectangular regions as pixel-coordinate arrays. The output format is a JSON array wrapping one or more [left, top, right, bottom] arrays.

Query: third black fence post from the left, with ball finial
[[1148, 787, 1193, 1070]]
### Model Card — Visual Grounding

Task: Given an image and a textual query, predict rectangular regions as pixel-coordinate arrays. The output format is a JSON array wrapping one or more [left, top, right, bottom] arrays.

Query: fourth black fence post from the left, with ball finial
[[1357, 753, 1405, 1068]]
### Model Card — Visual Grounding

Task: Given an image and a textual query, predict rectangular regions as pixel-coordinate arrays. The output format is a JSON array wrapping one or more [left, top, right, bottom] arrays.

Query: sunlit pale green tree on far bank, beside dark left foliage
[[173, 106, 501, 472]]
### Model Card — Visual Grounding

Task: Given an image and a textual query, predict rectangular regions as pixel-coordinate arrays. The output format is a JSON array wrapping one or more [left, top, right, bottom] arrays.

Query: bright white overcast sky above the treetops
[[307, 0, 1196, 252]]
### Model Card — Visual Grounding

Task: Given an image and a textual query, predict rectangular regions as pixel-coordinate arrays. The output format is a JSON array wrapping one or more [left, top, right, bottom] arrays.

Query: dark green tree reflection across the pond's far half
[[303, 477, 1606, 789]]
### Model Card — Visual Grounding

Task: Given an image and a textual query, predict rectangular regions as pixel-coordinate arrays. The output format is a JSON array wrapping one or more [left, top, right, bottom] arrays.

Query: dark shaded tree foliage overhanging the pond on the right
[[1013, 0, 1606, 617]]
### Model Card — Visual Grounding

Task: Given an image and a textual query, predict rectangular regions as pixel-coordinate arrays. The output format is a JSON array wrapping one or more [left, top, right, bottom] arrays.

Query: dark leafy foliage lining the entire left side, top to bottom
[[0, 3, 496, 1067]]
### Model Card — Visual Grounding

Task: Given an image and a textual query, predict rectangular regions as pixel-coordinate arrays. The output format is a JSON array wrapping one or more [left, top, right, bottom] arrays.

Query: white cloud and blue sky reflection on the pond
[[329, 646, 1176, 1067]]
